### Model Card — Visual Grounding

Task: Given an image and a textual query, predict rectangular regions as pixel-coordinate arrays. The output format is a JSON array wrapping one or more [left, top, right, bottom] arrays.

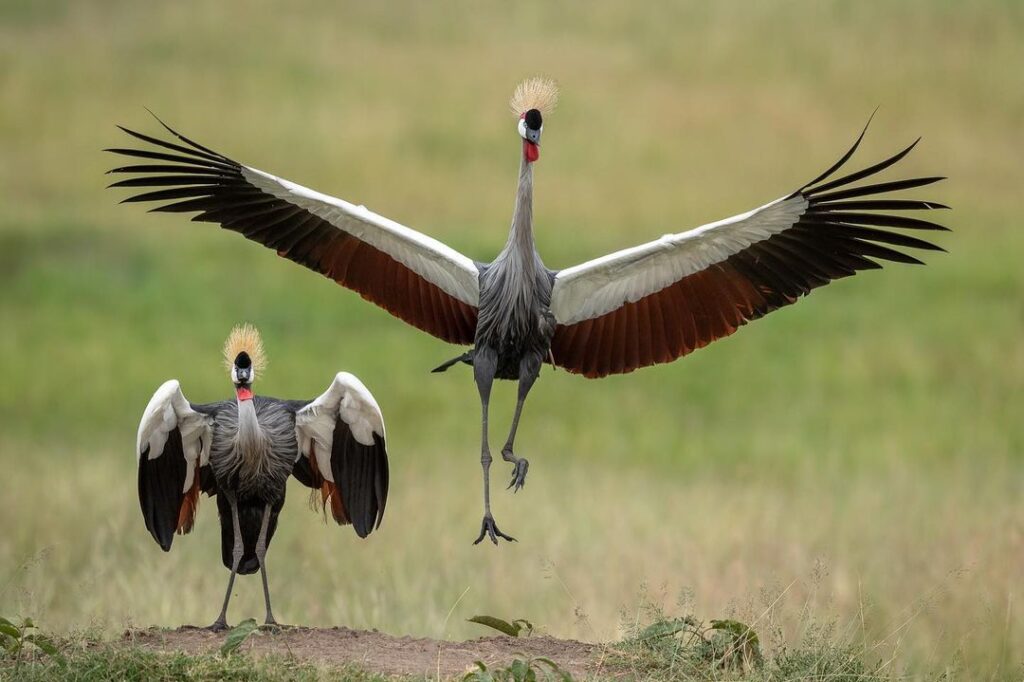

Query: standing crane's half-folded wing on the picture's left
[[135, 379, 217, 552]]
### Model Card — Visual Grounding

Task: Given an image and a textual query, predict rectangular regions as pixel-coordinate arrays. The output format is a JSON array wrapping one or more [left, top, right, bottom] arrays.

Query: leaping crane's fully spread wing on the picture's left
[[106, 119, 479, 344]]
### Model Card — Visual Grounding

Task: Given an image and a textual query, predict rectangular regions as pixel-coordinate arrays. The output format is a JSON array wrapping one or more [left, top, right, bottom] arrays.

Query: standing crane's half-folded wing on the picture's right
[[293, 372, 388, 538]]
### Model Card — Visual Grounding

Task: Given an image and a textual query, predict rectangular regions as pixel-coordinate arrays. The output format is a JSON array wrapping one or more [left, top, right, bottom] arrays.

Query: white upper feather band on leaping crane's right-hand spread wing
[[551, 195, 807, 325]]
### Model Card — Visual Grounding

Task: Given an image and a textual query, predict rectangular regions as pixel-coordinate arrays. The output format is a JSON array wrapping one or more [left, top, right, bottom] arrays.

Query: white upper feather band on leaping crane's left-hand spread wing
[[242, 166, 480, 307]]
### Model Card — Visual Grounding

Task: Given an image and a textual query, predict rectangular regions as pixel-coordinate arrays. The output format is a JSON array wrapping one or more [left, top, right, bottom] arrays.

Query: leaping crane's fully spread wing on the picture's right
[[551, 128, 948, 378]]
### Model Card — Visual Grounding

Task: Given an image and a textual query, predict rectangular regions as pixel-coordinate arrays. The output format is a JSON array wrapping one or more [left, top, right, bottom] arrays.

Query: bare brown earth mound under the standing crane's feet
[[122, 626, 607, 679]]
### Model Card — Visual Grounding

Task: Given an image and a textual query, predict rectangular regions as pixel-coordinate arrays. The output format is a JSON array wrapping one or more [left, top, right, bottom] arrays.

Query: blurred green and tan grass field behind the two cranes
[[0, 0, 1024, 680]]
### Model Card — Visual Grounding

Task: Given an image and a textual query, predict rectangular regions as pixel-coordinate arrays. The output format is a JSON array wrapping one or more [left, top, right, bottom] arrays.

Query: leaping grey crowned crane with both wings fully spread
[[108, 78, 948, 545]]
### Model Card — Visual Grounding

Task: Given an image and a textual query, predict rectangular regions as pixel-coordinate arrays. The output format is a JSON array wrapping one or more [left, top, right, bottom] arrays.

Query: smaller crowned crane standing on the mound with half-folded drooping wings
[[135, 325, 388, 630]]
